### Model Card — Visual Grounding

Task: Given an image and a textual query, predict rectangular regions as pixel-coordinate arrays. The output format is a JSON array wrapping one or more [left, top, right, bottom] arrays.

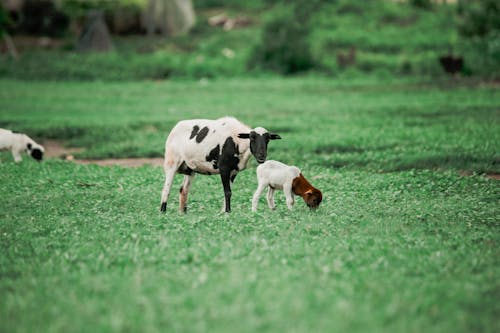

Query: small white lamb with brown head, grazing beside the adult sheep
[[252, 160, 323, 212]]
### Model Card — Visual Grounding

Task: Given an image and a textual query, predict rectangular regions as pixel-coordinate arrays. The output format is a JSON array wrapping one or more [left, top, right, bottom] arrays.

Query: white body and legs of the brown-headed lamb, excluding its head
[[252, 160, 300, 212]]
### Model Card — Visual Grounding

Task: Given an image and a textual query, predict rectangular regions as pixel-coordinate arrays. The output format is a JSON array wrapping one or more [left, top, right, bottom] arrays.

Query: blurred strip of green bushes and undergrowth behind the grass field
[[0, 0, 500, 80]]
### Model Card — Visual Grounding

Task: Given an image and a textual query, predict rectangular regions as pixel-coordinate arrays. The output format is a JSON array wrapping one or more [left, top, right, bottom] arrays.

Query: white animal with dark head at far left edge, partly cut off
[[0, 128, 44, 162]]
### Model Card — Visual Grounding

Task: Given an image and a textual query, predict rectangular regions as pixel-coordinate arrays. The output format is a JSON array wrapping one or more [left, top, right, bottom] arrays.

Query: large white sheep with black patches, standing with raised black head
[[160, 117, 281, 213]]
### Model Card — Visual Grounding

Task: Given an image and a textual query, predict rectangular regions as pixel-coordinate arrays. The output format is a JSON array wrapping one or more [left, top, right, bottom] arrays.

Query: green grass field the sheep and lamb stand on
[[0, 77, 500, 333]]
